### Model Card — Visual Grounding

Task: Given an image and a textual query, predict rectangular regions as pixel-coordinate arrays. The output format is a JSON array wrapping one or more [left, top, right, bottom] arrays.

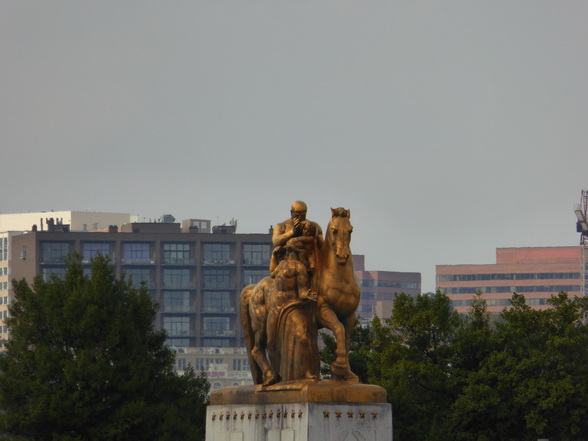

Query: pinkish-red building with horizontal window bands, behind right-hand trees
[[437, 247, 581, 312]]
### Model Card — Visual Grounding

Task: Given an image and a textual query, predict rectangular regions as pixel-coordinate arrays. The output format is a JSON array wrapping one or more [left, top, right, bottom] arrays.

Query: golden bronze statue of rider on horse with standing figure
[[241, 201, 360, 387]]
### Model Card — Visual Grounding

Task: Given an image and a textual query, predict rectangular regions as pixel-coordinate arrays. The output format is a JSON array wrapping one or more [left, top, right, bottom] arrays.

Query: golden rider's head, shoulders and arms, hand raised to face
[[270, 201, 323, 278]]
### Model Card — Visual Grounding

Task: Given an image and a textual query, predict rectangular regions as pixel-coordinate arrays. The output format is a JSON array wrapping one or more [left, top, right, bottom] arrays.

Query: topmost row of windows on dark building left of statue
[[41, 242, 271, 265]]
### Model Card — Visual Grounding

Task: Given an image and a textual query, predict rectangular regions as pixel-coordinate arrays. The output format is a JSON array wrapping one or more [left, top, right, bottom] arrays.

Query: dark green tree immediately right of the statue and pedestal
[[369, 291, 461, 440]]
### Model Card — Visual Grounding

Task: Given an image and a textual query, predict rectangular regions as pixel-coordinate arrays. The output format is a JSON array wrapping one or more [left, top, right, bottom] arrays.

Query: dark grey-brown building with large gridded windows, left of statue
[[6, 219, 272, 385]]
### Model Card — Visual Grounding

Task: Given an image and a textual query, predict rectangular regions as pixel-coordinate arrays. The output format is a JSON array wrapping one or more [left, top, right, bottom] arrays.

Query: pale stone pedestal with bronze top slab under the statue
[[206, 380, 392, 441]]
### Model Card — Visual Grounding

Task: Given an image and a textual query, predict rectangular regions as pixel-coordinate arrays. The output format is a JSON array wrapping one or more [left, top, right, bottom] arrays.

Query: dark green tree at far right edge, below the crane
[[452, 293, 588, 441]]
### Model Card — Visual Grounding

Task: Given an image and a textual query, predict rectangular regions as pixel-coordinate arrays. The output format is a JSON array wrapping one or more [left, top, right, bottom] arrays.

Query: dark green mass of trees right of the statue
[[342, 292, 588, 441]]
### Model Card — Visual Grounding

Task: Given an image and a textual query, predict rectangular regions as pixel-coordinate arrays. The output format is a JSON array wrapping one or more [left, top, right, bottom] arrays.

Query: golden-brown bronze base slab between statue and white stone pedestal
[[210, 380, 386, 405]]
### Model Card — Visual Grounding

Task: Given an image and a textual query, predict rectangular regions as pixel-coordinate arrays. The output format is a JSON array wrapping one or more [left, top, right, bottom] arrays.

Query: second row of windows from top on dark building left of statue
[[42, 266, 269, 289]]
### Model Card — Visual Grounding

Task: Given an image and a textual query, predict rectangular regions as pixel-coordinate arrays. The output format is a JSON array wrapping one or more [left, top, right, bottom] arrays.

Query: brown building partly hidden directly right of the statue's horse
[[353, 255, 421, 322]]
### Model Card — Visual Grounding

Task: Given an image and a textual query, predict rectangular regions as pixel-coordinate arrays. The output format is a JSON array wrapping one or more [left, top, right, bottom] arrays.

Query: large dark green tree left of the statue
[[0, 257, 208, 440]]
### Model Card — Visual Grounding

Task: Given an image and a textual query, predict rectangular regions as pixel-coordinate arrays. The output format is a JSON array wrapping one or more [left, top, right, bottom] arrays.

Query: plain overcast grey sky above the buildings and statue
[[0, 0, 588, 291]]
